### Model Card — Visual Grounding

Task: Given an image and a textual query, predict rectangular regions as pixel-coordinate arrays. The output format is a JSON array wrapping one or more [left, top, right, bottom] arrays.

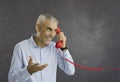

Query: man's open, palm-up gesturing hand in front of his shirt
[[27, 56, 48, 74]]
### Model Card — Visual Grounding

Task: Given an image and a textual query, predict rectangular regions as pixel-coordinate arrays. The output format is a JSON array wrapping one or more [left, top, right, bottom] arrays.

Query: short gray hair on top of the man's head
[[36, 14, 58, 24]]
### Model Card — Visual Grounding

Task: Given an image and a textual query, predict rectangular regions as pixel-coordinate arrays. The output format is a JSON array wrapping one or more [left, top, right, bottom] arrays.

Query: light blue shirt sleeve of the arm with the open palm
[[8, 45, 30, 82]]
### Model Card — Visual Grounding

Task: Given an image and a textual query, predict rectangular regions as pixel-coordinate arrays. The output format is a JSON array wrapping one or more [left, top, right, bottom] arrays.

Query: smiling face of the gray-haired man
[[38, 20, 58, 45]]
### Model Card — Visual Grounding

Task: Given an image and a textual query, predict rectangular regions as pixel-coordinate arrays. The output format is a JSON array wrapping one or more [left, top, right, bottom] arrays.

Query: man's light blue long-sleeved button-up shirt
[[8, 36, 75, 82]]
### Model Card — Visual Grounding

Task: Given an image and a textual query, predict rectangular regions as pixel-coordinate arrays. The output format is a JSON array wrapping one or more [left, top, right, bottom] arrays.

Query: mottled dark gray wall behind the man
[[0, 0, 120, 82]]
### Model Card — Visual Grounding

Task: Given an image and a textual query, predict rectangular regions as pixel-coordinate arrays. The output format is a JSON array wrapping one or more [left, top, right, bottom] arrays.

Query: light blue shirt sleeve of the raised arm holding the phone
[[58, 50, 75, 75]]
